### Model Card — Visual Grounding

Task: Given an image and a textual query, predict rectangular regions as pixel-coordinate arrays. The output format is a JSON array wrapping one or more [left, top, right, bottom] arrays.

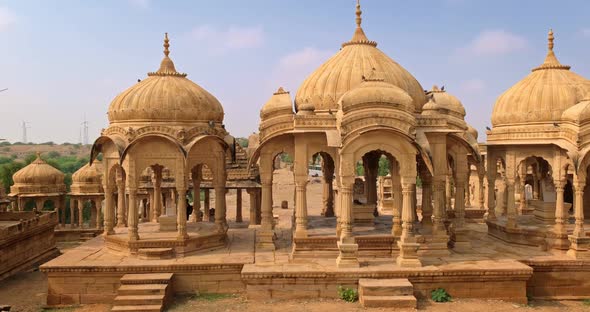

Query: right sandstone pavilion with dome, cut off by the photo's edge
[[486, 31, 590, 257]]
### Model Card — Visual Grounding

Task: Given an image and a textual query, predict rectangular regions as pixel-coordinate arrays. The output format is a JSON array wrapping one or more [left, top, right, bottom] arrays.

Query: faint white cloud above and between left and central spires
[[190, 25, 264, 51]]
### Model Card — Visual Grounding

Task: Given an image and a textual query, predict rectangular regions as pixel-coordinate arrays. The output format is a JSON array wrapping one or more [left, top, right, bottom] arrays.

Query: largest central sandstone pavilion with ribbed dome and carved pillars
[[251, 3, 479, 267]]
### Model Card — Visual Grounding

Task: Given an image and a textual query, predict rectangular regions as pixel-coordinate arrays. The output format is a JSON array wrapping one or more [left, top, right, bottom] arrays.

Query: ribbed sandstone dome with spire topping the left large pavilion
[[108, 34, 223, 124]]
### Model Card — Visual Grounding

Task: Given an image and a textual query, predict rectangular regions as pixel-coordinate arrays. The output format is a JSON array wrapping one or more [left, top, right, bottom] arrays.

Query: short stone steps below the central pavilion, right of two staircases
[[359, 278, 416, 309]]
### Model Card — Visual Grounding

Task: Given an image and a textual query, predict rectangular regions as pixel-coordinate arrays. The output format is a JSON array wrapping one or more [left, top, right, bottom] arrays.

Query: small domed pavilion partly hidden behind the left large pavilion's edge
[[68, 161, 104, 229]]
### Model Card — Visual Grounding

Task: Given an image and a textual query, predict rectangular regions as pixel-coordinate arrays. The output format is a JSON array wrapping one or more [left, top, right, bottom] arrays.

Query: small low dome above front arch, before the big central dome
[[340, 72, 414, 114]]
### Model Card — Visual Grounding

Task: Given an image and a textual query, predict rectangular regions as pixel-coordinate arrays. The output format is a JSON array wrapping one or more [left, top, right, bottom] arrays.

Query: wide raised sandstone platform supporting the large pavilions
[[41, 214, 590, 305]]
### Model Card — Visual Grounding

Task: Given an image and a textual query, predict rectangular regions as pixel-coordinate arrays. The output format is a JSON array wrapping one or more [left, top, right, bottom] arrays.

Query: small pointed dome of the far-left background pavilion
[[10, 153, 66, 193]]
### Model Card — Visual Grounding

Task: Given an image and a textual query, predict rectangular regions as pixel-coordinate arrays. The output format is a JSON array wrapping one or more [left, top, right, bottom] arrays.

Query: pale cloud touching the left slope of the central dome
[[269, 47, 334, 92]]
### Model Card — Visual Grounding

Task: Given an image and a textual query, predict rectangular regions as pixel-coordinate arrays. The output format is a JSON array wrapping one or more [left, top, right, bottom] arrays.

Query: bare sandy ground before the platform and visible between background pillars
[[0, 169, 590, 312]]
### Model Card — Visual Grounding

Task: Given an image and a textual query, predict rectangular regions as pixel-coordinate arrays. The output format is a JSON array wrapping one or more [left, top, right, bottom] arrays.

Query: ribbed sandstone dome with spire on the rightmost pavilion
[[492, 31, 590, 127]]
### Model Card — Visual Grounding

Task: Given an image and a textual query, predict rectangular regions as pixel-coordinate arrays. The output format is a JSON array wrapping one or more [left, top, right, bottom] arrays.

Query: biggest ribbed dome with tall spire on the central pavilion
[[295, 4, 426, 112]]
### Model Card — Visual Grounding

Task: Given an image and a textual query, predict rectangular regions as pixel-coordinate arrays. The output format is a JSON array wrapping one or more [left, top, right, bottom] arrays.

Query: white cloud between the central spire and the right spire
[[457, 30, 528, 56]]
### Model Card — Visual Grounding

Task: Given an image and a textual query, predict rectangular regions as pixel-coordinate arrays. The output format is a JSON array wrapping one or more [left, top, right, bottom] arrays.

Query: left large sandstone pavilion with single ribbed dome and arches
[[91, 34, 228, 253]]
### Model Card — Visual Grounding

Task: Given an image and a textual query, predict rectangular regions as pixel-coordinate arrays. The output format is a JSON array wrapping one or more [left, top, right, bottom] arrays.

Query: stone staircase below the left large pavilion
[[111, 273, 173, 312]]
